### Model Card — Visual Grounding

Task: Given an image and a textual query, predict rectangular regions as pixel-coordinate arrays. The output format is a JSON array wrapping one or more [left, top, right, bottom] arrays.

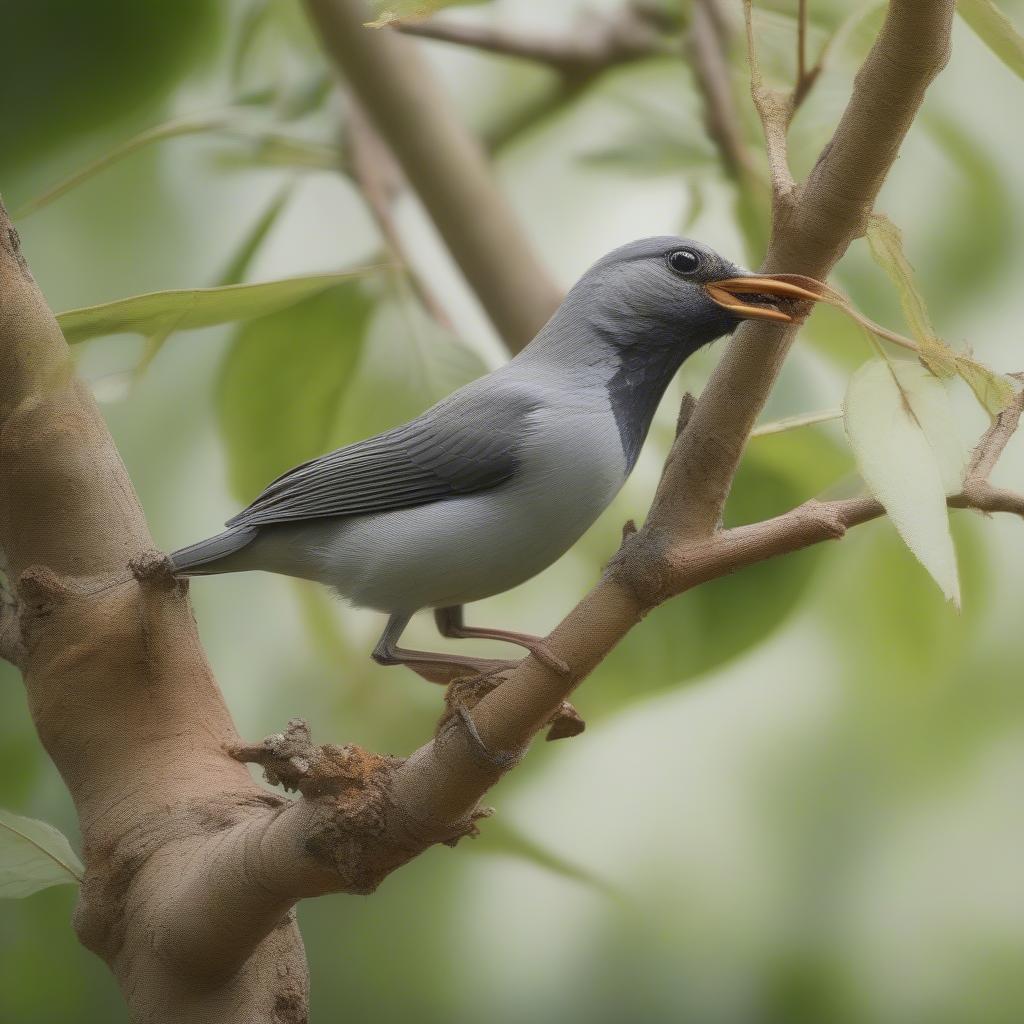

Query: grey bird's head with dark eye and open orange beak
[[556, 236, 817, 358]]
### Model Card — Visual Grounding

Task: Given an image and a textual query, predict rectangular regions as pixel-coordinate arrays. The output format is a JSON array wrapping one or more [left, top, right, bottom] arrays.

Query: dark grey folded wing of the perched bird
[[227, 378, 539, 526]]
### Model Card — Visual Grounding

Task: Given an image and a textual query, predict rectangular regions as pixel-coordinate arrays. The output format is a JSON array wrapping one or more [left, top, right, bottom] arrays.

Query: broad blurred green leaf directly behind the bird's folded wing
[[217, 280, 374, 501]]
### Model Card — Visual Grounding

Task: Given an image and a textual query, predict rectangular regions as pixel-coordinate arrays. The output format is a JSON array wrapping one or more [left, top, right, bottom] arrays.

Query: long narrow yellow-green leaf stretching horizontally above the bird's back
[[57, 267, 376, 345]]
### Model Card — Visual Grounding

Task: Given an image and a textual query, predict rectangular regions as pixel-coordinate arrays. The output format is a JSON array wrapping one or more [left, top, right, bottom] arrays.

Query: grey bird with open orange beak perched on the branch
[[170, 236, 818, 682]]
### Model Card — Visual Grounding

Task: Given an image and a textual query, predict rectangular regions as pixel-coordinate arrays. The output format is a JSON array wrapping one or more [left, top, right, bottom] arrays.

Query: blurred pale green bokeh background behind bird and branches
[[0, 0, 1024, 1024]]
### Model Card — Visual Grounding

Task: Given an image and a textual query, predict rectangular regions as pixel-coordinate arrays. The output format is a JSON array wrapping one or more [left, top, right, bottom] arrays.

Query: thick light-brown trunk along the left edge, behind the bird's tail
[[0, 207, 306, 1024]]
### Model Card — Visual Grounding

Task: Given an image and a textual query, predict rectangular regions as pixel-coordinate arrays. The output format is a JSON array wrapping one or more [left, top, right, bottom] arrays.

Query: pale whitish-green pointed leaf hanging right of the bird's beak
[[844, 359, 964, 607]]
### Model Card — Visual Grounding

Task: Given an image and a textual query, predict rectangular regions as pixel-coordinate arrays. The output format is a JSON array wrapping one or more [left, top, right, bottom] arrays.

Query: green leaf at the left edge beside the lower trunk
[[0, 810, 84, 899]]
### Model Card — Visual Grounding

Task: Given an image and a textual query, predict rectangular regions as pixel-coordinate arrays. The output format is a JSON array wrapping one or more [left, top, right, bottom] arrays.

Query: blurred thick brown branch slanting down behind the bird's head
[[306, 0, 561, 352]]
